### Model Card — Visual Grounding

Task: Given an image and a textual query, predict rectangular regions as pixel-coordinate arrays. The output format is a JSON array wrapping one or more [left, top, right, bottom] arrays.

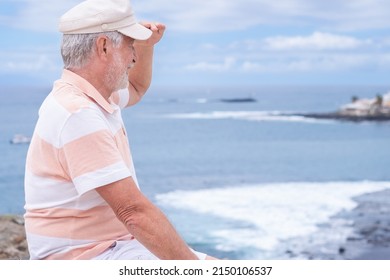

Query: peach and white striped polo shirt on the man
[[25, 70, 138, 259]]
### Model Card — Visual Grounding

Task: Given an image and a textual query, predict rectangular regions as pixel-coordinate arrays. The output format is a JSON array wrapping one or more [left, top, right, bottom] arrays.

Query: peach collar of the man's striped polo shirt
[[61, 69, 116, 114]]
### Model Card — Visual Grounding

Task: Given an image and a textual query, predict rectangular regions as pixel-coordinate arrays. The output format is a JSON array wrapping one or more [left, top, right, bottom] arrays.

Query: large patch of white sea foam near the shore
[[156, 181, 390, 257]]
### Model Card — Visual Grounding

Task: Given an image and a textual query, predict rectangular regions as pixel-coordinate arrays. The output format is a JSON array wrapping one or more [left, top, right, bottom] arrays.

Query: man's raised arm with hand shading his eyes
[[127, 23, 165, 106]]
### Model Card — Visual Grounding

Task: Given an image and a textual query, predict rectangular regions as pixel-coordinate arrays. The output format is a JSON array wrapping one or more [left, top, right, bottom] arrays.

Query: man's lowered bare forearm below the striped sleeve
[[96, 177, 198, 260]]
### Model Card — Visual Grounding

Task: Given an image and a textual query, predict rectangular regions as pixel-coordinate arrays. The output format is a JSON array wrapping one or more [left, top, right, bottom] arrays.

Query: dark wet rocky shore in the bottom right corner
[[292, 190, 390, 260]]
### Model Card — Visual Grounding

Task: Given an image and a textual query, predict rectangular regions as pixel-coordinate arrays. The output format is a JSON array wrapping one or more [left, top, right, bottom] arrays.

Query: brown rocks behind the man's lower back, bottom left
[[0, 215, 29, 260]]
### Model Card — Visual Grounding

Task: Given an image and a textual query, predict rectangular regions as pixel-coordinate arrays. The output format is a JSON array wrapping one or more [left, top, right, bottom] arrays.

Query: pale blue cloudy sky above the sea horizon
[[0, 0, 390, 86]]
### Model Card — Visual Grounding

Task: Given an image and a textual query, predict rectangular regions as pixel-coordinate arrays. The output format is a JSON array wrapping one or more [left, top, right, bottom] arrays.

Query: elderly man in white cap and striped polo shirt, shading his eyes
[[25, 0, 216, 259]]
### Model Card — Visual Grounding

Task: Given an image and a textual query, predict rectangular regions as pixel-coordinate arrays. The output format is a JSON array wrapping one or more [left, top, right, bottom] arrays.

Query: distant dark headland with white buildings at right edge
[[294, 92, 390, 122]]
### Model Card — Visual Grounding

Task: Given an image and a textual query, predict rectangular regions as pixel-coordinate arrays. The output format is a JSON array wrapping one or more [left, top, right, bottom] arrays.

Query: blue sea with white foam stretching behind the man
[[0, 85, 390, 259]]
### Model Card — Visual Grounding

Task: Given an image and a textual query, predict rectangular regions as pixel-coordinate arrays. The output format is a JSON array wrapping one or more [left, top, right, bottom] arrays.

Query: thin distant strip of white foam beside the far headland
[[166, 111, 332, 123]]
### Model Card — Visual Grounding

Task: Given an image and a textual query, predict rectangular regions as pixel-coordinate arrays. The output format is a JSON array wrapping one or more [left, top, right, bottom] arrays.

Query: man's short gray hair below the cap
[[61, 31, 123, 69]]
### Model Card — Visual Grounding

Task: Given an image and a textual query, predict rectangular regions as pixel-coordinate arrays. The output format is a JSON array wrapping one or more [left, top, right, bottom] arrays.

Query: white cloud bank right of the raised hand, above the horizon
[[186, 32, 390, 73]]
